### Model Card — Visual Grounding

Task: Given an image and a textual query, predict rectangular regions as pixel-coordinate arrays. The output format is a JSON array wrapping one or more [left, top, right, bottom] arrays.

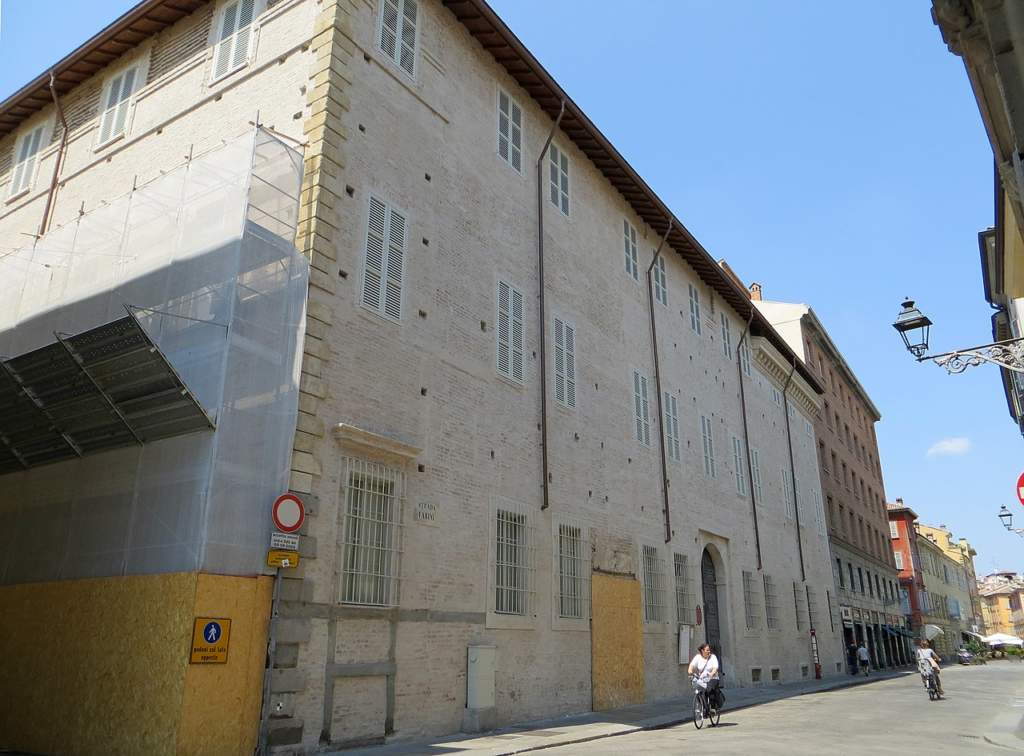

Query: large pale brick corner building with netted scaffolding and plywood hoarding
[[0, 0, 843, 753]]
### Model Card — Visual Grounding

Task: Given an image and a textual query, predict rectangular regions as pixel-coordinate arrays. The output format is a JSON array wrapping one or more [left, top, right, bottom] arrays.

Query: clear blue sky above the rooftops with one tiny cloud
[[0, 0, 1024, 574]]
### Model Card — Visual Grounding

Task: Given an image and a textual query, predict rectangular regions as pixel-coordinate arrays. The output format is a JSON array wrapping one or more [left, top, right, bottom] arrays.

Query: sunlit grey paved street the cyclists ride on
[[549, 663, 1024, 756]]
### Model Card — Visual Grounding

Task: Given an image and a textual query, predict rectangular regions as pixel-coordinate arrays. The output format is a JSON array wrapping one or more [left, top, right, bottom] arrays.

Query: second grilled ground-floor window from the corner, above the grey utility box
[[492, 508, 535, 615]]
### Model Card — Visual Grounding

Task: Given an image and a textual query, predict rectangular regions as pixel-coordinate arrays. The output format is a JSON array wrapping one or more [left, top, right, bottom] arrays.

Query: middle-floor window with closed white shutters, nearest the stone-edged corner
[[362, 197, 406, 321]]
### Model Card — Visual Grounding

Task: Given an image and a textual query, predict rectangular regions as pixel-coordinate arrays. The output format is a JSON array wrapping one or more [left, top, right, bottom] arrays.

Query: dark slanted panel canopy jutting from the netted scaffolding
[[0, 312, 214, 474]]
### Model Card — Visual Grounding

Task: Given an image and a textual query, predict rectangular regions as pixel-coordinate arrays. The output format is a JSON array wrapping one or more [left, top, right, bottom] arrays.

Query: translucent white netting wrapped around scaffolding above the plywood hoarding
[[0, 129, 309, 584]]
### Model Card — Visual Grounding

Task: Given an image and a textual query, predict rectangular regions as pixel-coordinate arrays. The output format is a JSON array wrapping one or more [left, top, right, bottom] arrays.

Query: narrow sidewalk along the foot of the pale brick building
[[331, 668, 916, 756]]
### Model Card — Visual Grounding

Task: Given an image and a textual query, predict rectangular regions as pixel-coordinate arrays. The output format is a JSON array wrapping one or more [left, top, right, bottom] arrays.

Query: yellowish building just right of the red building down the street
[[918, 522, 977, 657]]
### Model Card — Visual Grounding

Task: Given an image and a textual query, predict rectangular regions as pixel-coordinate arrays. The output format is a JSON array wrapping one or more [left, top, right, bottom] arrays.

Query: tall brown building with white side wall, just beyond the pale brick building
[[751, 284, 904, 667]]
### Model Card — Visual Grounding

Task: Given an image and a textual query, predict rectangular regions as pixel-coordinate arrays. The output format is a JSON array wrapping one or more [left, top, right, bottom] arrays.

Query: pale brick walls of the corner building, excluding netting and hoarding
[[0, 0, 847, 752]]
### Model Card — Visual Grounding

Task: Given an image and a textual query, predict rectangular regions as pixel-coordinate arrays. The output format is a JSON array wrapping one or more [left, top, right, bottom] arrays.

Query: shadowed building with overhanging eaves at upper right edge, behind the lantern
[[932, 0, 1024, 432]]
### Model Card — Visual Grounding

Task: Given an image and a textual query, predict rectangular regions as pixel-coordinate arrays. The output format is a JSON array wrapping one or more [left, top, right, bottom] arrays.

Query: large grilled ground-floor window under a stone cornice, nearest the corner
[[340, 458, 406, 606]]
